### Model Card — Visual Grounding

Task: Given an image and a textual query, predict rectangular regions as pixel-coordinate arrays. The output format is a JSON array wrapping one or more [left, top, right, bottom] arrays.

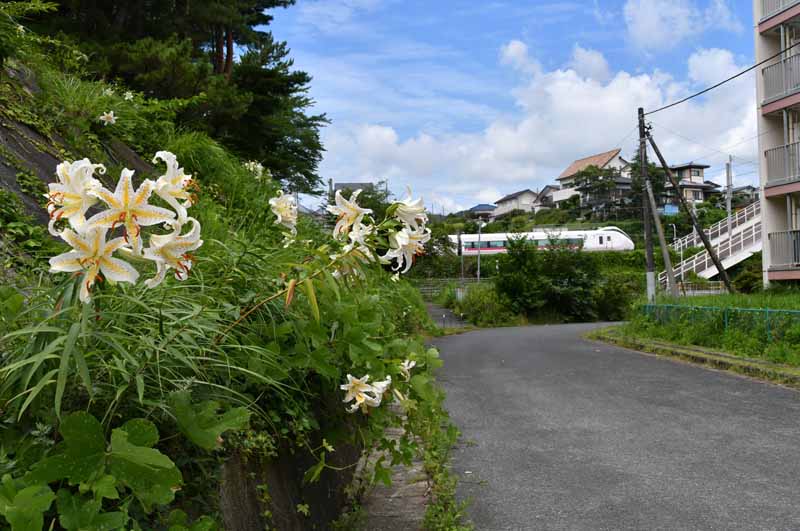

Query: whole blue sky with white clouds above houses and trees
[[272, 0, 756, 211]]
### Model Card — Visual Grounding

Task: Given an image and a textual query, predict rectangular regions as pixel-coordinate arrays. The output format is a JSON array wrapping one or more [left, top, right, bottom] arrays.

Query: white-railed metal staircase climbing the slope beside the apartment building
[[658, 201, 762, 287]]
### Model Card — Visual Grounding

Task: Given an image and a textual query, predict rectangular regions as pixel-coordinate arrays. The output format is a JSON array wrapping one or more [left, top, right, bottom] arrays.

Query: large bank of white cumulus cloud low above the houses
[[323, 41, 756, 210]]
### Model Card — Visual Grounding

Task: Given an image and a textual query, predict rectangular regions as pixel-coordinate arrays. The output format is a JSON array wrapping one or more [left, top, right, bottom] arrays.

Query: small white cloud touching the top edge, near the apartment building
[[623, 0, 744, 52]]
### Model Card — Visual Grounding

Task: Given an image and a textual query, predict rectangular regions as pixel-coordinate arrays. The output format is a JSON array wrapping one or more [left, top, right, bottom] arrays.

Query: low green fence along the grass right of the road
[[642, 304, 800, 341]]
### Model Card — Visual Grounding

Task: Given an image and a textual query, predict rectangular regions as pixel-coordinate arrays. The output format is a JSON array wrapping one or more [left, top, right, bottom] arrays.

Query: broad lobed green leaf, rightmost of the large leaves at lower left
[[169, 391, 250, 451]]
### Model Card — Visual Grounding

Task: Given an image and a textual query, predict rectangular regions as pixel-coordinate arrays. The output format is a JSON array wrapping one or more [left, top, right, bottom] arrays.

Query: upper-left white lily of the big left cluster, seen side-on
[[45, 159, 106, 236]]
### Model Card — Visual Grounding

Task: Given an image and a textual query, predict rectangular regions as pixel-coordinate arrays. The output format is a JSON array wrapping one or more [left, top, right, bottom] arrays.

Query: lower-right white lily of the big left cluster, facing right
[[143, 218, 203, 288]]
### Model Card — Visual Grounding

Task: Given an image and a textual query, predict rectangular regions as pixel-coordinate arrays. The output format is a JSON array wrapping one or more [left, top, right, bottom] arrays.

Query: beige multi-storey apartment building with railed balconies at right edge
[[753, 0, 800, 284]]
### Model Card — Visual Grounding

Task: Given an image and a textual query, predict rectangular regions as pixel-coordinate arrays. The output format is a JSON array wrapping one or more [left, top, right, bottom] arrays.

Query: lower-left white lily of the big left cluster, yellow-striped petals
[[50, 227, 139, 302]]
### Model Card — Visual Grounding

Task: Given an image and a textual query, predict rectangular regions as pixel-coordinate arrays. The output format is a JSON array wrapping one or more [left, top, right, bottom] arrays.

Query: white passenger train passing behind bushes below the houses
[[448, 227, 634, 256]]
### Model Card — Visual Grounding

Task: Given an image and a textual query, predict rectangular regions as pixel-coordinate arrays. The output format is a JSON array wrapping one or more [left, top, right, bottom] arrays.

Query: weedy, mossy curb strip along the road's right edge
[[586, 327, 800, 389]]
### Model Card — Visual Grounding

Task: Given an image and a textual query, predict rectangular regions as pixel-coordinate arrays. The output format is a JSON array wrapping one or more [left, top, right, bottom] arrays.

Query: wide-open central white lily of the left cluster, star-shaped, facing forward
[[86, 168, 175, 255]]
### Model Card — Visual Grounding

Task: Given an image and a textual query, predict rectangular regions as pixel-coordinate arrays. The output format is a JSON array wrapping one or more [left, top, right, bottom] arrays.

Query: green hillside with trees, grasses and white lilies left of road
[[0, 1, 468, 530]]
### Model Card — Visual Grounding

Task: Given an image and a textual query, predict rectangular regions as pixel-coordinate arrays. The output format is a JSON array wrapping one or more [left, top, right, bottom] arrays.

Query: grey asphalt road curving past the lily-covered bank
[[436, 325, 800, 530]]
